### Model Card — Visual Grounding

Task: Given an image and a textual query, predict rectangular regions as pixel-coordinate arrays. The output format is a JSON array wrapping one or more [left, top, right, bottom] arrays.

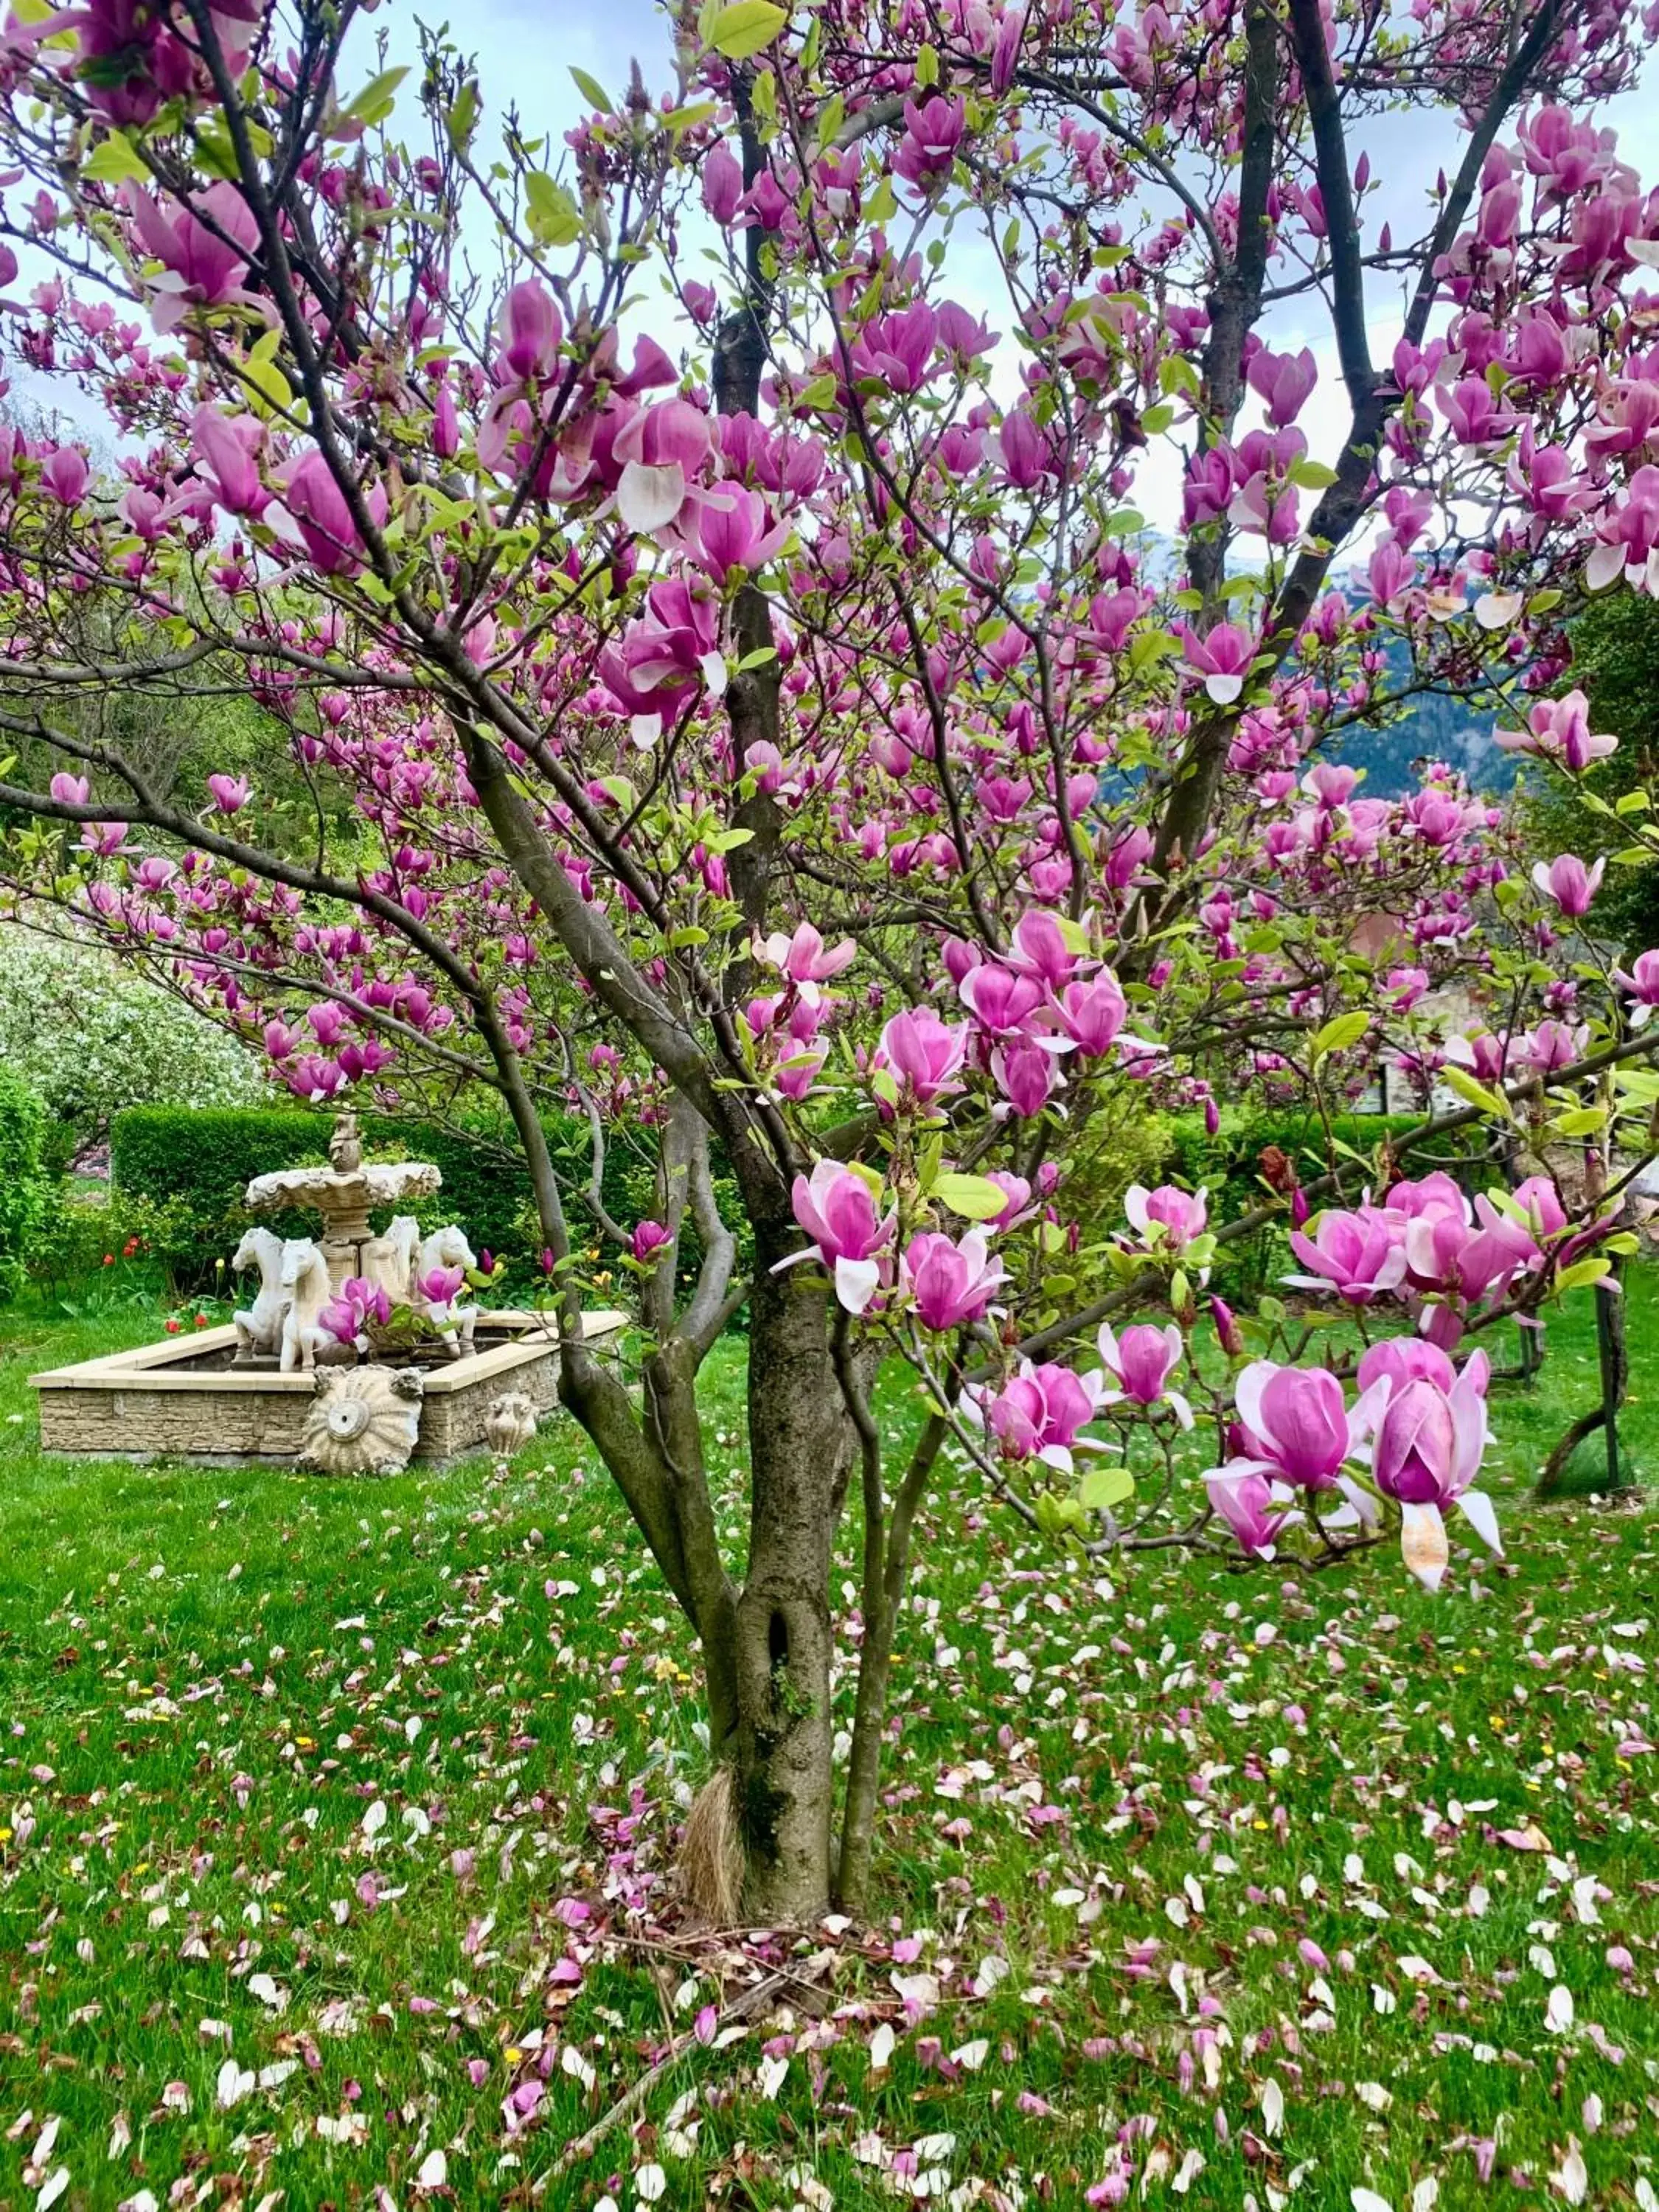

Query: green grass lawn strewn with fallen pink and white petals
[[0, 1274, 1659, 2212]]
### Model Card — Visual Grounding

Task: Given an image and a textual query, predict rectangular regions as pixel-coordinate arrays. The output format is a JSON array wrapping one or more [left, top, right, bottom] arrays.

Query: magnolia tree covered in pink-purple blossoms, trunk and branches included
[[0, 0, 1659, 1920]]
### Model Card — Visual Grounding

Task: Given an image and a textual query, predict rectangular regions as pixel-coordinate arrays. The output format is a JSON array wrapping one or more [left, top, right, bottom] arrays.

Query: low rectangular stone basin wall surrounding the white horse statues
[[29, 1310, 626, 1467]]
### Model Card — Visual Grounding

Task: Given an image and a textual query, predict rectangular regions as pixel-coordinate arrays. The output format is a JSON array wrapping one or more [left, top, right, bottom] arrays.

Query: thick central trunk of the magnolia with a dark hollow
[[730, 1248, 845, 1924]]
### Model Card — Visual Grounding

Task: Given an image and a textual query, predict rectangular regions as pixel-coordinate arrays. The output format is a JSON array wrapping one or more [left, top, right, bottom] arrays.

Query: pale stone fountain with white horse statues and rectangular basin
[[29, 1113, 626, 1473]]
